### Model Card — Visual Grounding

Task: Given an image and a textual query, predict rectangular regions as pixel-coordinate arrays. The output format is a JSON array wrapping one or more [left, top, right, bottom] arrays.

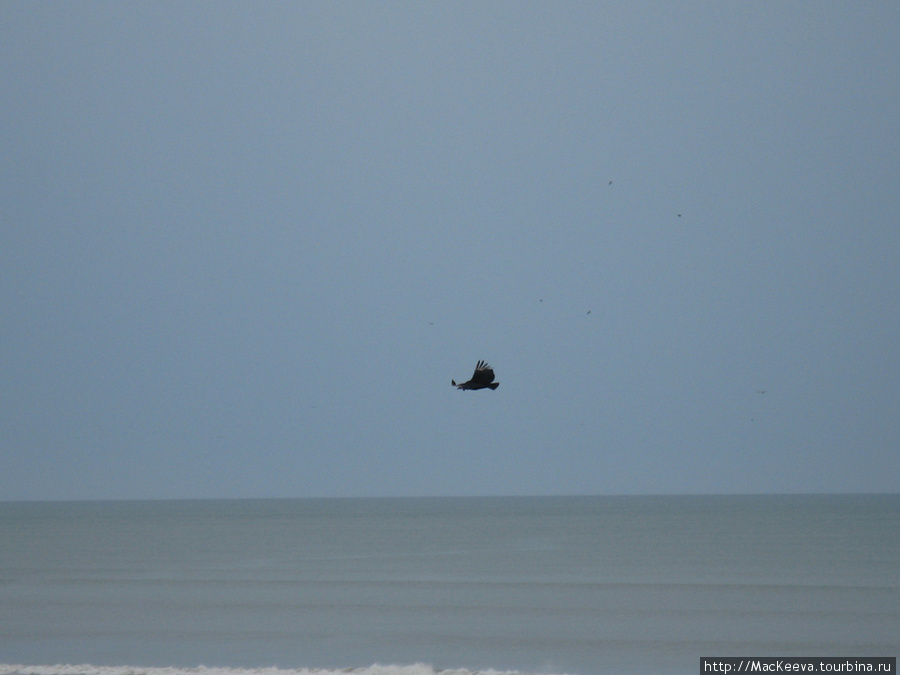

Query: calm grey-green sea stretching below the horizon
[[0, 495, 900, 675]]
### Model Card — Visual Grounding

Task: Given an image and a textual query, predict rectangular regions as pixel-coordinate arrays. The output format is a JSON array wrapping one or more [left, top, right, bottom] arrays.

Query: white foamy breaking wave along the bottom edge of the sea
[[0, 663, 564, 675]]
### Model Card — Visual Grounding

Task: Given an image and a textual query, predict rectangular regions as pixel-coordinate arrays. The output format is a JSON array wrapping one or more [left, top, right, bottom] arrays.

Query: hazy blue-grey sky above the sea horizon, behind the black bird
[[0, 0, 900, 500]]
